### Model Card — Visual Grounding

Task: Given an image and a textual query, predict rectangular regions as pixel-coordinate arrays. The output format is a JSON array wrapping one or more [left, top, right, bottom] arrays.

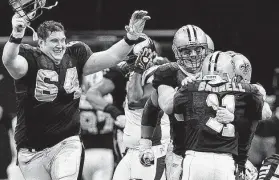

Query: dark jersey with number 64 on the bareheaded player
[[15, 42, 92, 148]]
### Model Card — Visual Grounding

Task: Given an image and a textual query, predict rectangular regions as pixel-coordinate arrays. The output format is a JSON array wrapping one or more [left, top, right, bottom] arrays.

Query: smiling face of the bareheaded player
[[40, 31, 66, 61]]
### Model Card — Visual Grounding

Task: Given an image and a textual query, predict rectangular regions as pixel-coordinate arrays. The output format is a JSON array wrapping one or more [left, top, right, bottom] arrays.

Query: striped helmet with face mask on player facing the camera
[[172, 25, 208, 73]]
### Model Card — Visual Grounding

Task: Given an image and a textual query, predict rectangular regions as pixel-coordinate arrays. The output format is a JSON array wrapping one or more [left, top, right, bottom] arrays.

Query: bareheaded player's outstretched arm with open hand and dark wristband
[[83, 10, 150, 75]]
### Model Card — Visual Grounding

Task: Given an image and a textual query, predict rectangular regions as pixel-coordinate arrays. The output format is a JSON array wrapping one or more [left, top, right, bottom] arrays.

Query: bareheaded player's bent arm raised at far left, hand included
[[2, 15, 28, 79]]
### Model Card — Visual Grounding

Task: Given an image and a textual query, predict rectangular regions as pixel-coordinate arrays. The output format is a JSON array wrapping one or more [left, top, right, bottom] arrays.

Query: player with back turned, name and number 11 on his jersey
[[142, 51, 270, 180]]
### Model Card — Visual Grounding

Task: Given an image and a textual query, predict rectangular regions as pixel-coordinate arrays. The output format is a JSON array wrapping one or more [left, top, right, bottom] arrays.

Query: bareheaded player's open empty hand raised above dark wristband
[[125, 10, 151, 40]]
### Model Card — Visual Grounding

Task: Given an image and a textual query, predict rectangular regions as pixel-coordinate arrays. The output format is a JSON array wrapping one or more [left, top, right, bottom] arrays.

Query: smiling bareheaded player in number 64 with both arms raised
[[2, 7, 150, 180]]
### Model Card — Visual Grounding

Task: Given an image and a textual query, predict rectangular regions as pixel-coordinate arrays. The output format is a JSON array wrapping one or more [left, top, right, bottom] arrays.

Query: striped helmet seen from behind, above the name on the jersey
[[202, 51, 235, 82]]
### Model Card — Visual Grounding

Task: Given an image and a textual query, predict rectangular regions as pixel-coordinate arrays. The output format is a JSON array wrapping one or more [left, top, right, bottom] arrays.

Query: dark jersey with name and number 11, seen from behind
[[173, 81, 263, 155]]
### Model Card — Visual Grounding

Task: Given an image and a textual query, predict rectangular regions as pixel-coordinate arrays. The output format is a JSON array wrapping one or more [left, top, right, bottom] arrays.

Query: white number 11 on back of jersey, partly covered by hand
[[206, 94, 235, 137]]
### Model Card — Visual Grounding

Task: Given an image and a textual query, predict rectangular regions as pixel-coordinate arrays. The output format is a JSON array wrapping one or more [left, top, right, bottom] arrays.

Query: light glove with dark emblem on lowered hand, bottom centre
[[139, 139, 154, 167]]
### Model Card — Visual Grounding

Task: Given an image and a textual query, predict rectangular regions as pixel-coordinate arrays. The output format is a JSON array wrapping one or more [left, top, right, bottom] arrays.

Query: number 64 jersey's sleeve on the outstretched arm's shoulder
[[67, 41, 93, 71]]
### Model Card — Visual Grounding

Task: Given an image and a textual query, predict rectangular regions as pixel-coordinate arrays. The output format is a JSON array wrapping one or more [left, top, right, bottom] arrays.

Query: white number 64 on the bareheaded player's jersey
[[35, 67, 81, 102]]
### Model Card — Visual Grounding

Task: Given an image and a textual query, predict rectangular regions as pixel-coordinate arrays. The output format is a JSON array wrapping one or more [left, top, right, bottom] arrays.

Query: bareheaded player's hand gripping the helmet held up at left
[[12, 13, 29, 38]]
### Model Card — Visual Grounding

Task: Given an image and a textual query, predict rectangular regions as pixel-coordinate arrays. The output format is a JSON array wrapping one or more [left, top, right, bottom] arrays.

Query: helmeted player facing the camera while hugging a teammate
[[142, 25, 211, 180]]
